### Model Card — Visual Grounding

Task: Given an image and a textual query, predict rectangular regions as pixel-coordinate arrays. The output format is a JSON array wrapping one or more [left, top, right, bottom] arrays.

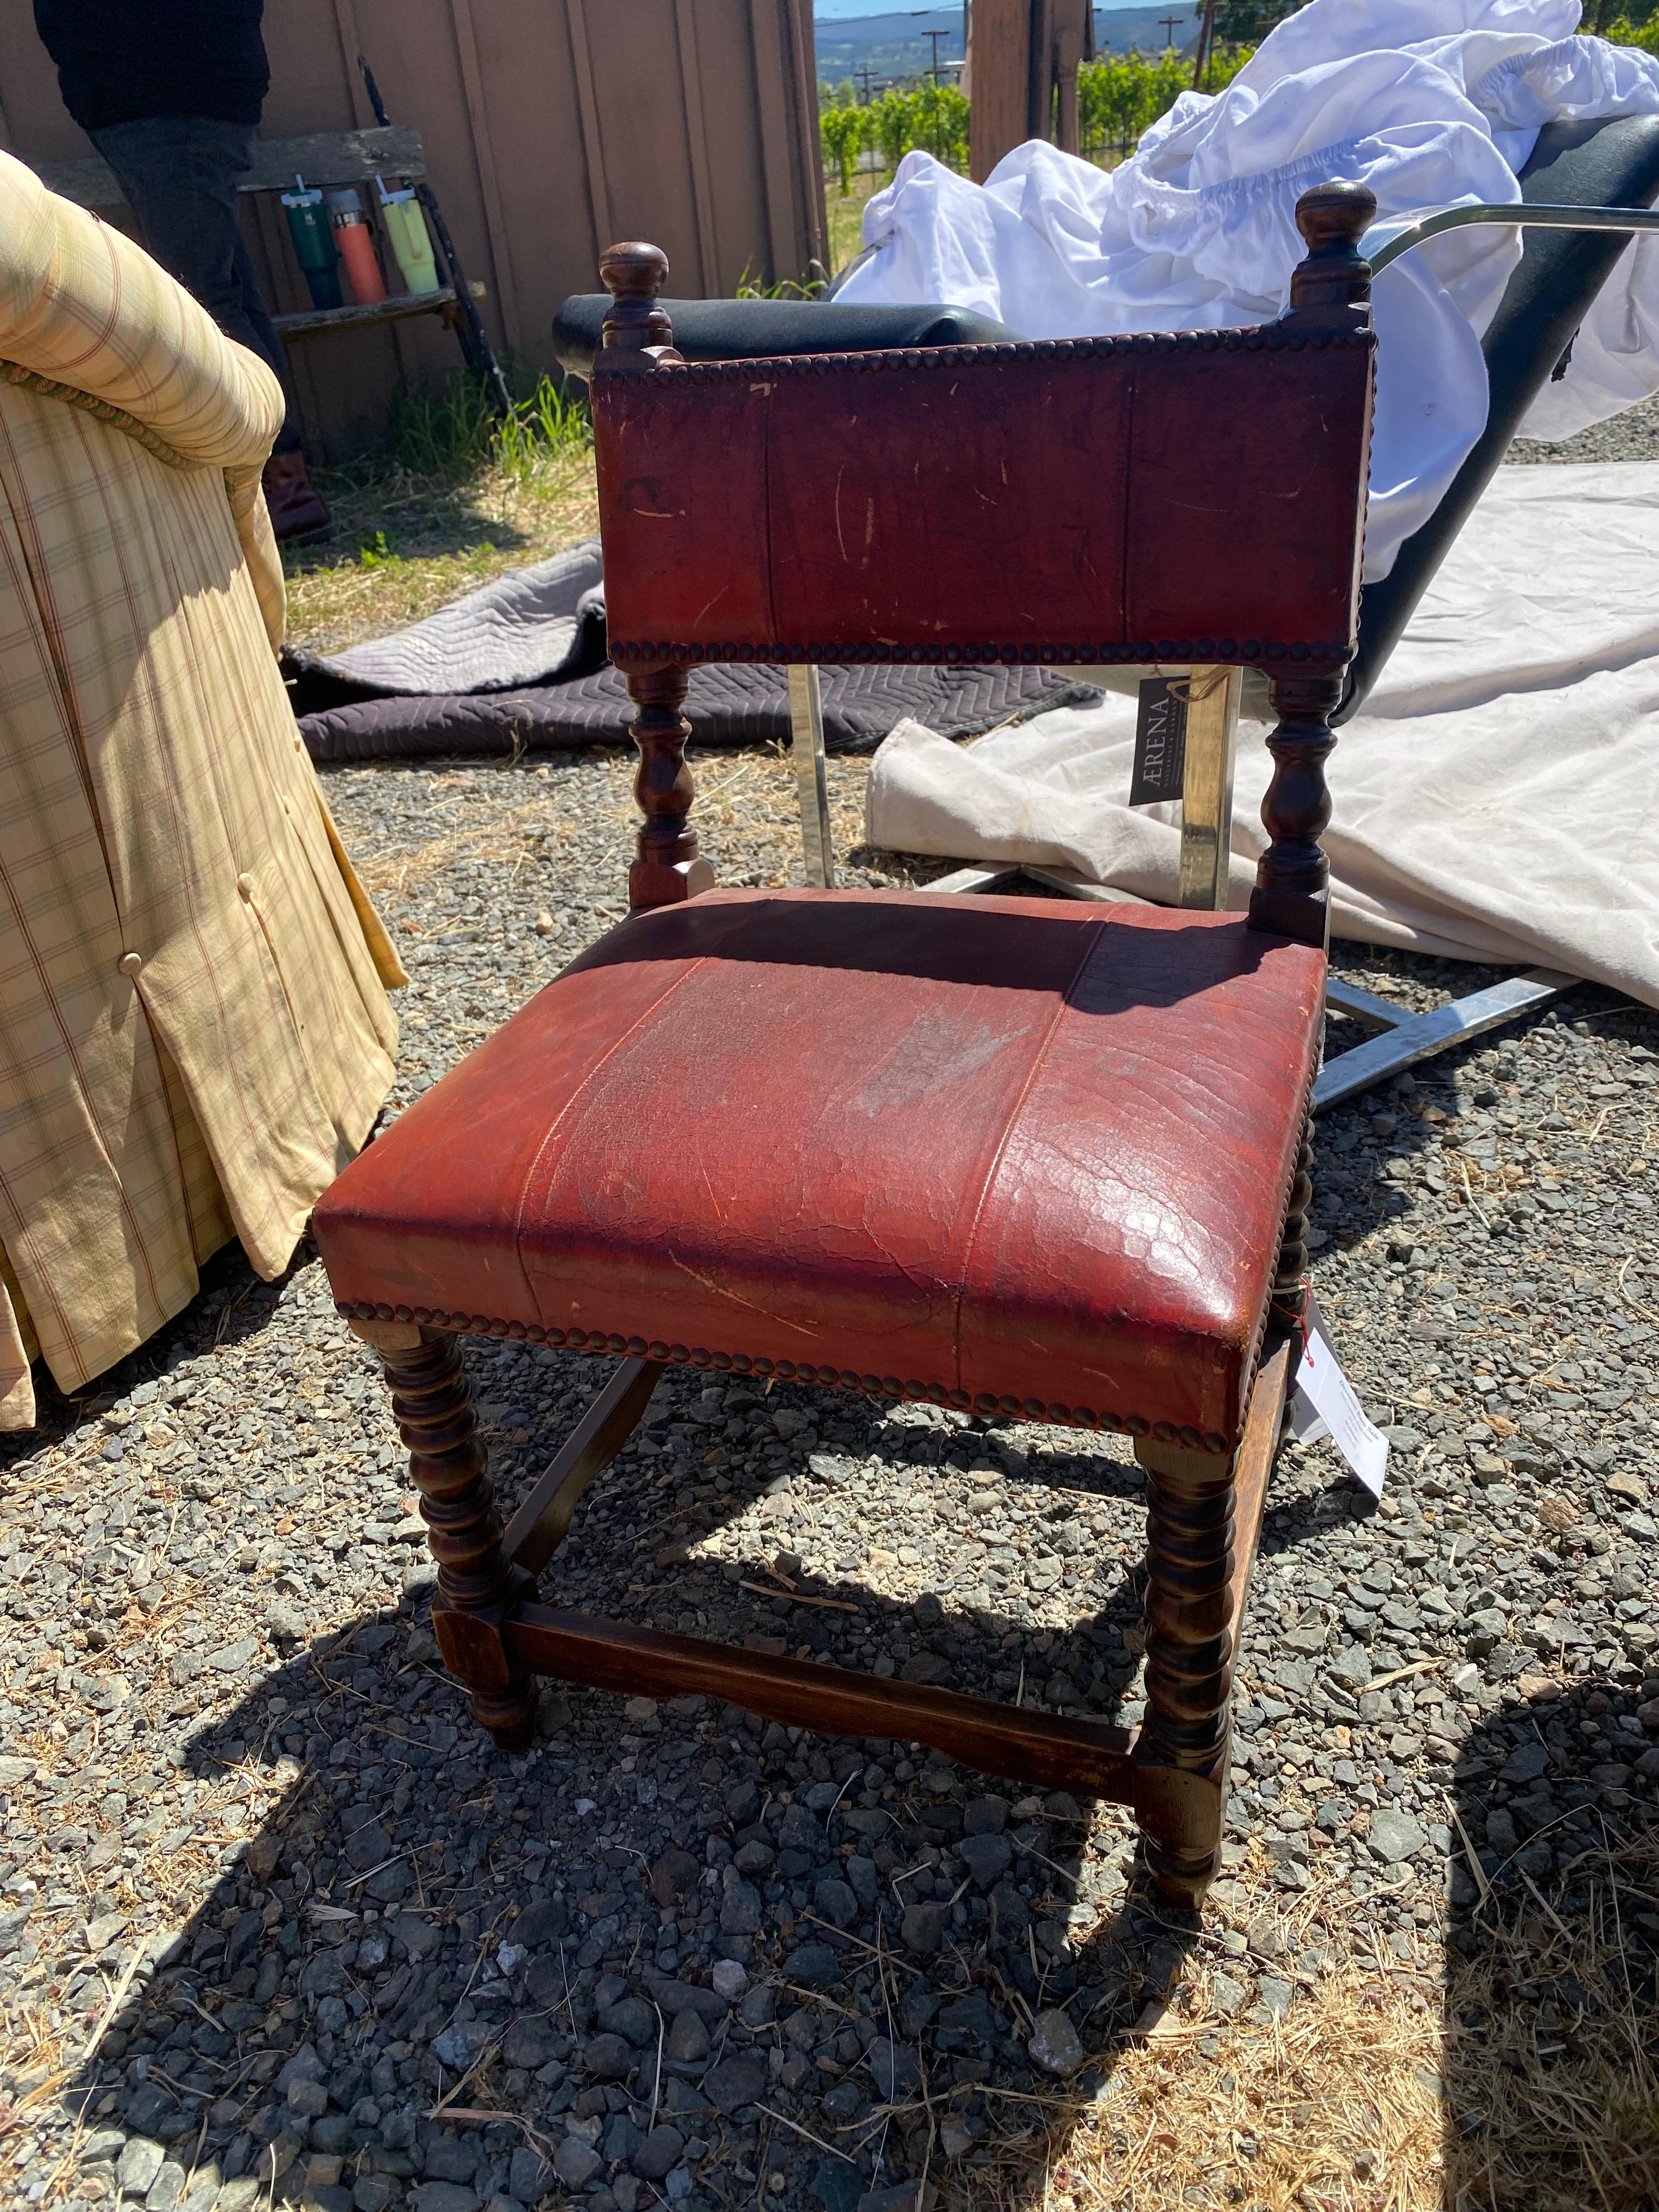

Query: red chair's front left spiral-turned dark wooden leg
[[352, 1321, 535, 1752]]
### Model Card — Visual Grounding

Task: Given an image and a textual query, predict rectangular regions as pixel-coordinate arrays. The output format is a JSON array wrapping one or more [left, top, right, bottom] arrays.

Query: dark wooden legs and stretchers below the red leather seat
[[349, 1321, 1296, 1903]]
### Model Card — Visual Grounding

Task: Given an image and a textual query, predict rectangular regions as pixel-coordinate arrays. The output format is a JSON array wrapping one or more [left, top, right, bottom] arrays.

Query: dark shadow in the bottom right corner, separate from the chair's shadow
[[1442, 1674, 1659, 2212]]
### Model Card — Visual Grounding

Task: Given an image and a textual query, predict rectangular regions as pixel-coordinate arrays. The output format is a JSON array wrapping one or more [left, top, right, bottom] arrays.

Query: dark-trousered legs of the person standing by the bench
[[93, 115, 330, 538]]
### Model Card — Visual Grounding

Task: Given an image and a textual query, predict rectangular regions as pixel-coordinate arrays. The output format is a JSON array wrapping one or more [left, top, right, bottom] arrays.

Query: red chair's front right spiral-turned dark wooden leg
[[1135, 1440, 1234, 1911]]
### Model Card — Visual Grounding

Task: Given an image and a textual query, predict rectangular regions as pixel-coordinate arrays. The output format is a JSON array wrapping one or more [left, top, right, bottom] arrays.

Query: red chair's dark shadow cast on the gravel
[[48, 1300, 1353, 2212]]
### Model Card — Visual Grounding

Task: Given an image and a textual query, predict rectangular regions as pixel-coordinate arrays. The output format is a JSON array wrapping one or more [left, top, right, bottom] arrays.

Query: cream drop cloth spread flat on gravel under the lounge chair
[[865, 462, 1659, 1007]]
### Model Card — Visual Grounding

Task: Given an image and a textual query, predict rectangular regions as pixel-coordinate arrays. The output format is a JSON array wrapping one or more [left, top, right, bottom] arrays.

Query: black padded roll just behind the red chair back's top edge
[[553, 292, 1022, 376]]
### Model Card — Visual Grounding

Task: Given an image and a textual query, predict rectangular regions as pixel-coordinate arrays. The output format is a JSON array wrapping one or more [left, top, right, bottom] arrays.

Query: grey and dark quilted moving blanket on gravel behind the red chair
[[283, 538, 1097, 761]]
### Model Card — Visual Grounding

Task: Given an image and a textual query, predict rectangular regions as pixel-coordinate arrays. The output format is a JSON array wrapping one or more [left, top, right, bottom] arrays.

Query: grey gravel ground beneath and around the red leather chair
[[0, 436, 1659, 2212]]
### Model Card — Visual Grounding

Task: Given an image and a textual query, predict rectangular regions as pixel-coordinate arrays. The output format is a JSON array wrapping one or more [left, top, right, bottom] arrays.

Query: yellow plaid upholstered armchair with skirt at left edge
[[0, 155, 403, 1427]]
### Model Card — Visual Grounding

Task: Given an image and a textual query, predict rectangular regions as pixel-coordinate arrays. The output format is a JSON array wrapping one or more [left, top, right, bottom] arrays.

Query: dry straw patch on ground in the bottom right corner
[[946, 1834, 1659, 2212]]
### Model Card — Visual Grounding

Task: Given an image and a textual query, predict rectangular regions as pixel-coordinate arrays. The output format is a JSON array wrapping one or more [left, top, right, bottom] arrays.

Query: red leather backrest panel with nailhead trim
[[593, 317, 1374, 675]]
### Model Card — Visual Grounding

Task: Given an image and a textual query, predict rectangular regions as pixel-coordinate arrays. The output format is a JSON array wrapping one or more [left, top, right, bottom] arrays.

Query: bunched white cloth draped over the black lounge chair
[[838, 0, 1659, 579]]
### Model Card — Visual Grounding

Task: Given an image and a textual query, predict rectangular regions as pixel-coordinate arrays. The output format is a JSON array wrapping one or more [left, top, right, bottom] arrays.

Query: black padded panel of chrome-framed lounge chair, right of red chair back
[[1331, 115, 1659, 721]]
